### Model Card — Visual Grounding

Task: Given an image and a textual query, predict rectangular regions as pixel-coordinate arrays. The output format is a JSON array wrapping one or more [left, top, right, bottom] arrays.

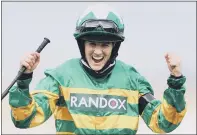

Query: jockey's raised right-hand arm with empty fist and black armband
[[139, 54, 186, 133]]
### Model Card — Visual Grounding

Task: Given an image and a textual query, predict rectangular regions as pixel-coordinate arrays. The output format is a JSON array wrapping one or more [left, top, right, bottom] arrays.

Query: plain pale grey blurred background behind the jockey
[[1, 2, 196, 134]]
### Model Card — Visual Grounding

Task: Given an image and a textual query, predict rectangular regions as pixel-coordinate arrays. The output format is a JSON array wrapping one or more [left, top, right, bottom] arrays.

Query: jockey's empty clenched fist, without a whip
[[165, 53, 182, 77]]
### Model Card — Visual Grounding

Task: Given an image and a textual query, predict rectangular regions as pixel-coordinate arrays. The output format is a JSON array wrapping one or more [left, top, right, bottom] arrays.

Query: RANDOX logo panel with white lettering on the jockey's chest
[[70, 93, 127, 113]]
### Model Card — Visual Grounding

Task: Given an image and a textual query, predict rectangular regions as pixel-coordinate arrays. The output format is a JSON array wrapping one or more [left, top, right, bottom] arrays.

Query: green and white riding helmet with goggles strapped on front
[[74, 4, 124, 42]]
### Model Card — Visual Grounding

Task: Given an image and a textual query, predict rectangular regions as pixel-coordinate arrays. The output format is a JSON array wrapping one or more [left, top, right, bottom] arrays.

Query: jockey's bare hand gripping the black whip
[[20, 52, 40, 73]]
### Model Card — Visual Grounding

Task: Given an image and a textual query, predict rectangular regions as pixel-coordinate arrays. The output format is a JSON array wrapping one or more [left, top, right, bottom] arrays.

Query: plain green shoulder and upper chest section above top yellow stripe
[[45, 59, 140, 90]]
